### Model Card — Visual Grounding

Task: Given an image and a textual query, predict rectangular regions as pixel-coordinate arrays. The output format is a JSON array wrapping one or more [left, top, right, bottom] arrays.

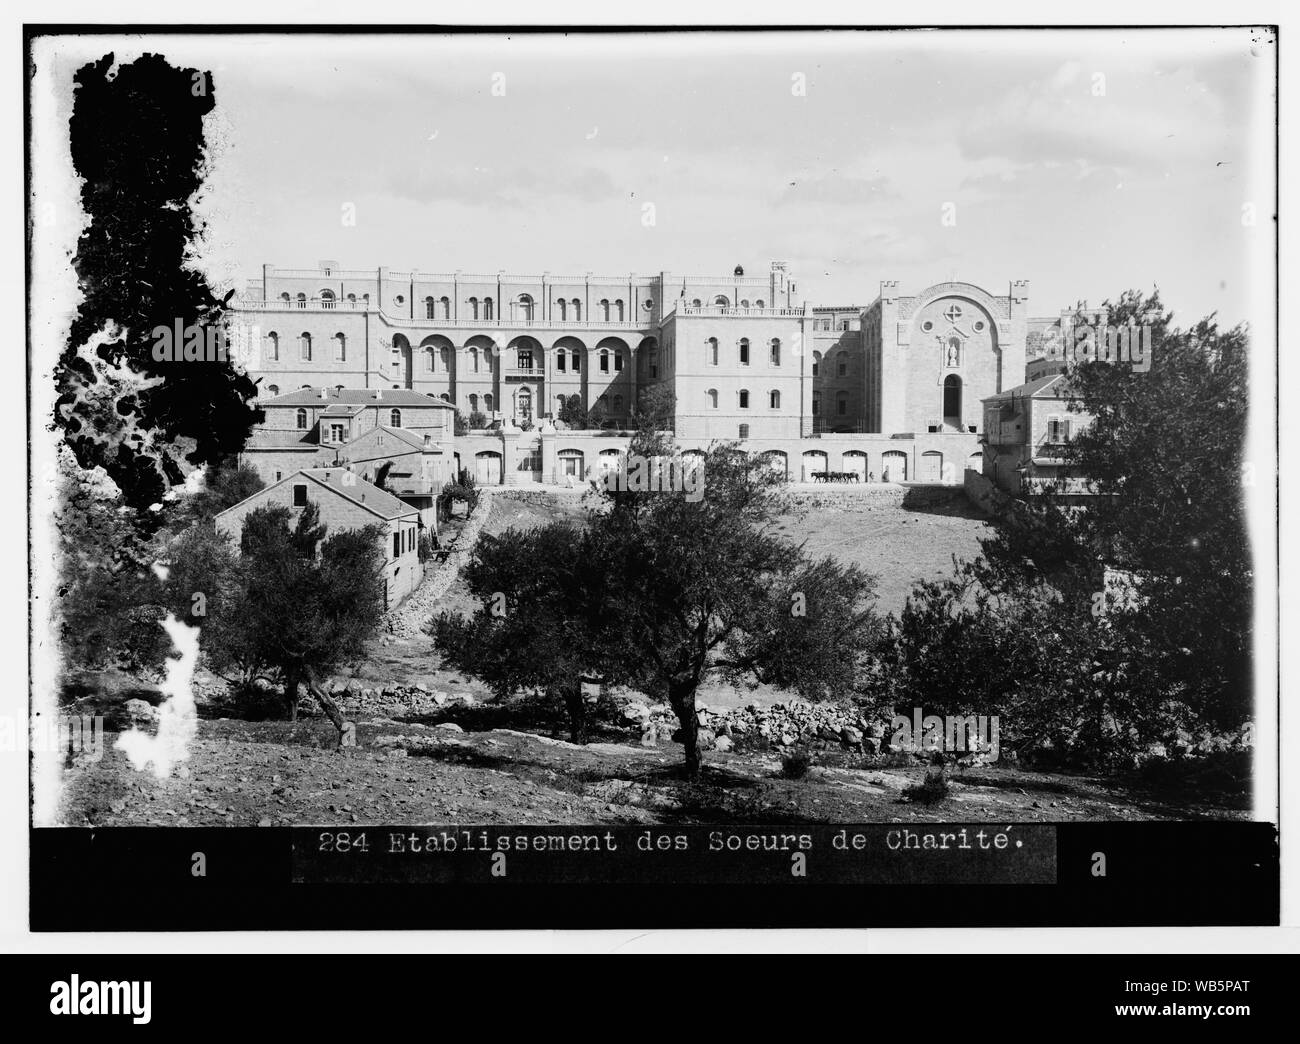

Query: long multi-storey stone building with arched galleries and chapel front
[[234, 261, 1092, 482]]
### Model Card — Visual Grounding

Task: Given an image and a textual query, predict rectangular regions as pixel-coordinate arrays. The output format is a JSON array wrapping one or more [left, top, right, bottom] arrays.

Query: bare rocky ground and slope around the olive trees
[[59, 490, 1251, 826]]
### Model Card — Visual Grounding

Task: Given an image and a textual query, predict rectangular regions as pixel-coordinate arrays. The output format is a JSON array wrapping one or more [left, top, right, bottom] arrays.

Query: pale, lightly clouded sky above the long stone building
[[38, 30, 1275, 322]]
